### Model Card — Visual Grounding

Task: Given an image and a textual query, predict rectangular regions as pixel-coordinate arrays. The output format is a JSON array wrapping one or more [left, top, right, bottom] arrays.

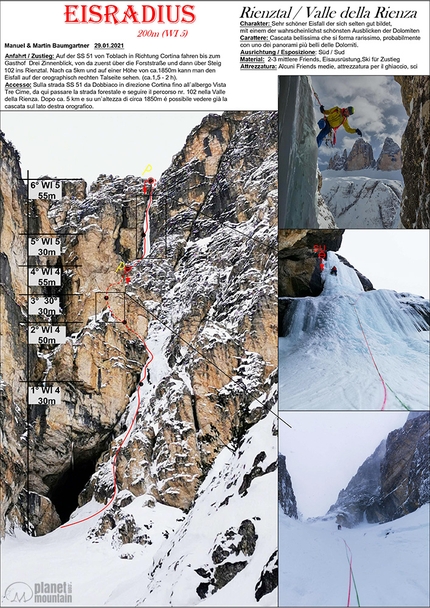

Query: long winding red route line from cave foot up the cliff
[[60, 184, 154, 528]]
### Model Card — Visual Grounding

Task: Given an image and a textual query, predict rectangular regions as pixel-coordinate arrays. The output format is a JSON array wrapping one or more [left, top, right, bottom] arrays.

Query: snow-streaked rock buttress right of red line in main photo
[[78, 114, 277, 509]]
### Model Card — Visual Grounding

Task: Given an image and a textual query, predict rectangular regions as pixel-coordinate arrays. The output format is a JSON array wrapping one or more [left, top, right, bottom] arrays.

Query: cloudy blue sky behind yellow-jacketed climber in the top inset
[[312, 75, 408, 169]]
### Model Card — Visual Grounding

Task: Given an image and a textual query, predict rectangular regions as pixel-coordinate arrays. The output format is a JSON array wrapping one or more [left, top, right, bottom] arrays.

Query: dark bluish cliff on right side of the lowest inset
[[327, 412, 430, 527]]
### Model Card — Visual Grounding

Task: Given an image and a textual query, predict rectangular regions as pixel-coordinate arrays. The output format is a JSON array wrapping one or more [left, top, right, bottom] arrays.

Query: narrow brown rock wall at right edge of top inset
[[394, 76, 430, 228]]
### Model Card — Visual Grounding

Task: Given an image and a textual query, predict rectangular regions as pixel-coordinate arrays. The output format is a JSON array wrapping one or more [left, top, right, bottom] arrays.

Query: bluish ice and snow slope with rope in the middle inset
[[279, 251, 429, 410]]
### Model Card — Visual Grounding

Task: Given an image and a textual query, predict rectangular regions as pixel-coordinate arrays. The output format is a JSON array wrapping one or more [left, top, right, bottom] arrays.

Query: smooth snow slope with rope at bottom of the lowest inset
[[279, 504, 429, 606]]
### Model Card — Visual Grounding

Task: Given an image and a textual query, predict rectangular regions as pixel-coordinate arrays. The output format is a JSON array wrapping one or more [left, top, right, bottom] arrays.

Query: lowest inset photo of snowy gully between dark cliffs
[[279, 412, 430, 607]]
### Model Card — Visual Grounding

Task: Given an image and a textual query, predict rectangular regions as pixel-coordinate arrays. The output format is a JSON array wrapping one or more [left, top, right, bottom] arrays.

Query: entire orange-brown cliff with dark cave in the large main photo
[[1, 112, 278, 605]]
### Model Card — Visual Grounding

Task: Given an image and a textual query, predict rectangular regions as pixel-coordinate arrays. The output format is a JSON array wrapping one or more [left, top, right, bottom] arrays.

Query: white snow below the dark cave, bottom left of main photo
[[1, 496, 183, 606]]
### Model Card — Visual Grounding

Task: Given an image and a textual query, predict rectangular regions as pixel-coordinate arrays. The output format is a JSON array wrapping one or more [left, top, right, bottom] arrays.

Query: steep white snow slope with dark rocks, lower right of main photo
[[127, 402, 277, 606]]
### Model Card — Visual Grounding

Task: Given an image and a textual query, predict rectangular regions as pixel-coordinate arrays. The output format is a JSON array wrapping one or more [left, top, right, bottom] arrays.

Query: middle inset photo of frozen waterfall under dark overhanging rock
[[279, 230, 429, 411]]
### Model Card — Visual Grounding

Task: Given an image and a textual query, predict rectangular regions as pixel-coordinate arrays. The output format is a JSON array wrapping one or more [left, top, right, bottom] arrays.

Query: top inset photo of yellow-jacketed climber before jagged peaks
[[279, 75, 430, 229]]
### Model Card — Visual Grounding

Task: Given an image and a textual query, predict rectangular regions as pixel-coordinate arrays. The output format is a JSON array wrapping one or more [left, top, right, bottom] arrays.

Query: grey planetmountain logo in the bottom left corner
[[3, 581, 72, 604]]
